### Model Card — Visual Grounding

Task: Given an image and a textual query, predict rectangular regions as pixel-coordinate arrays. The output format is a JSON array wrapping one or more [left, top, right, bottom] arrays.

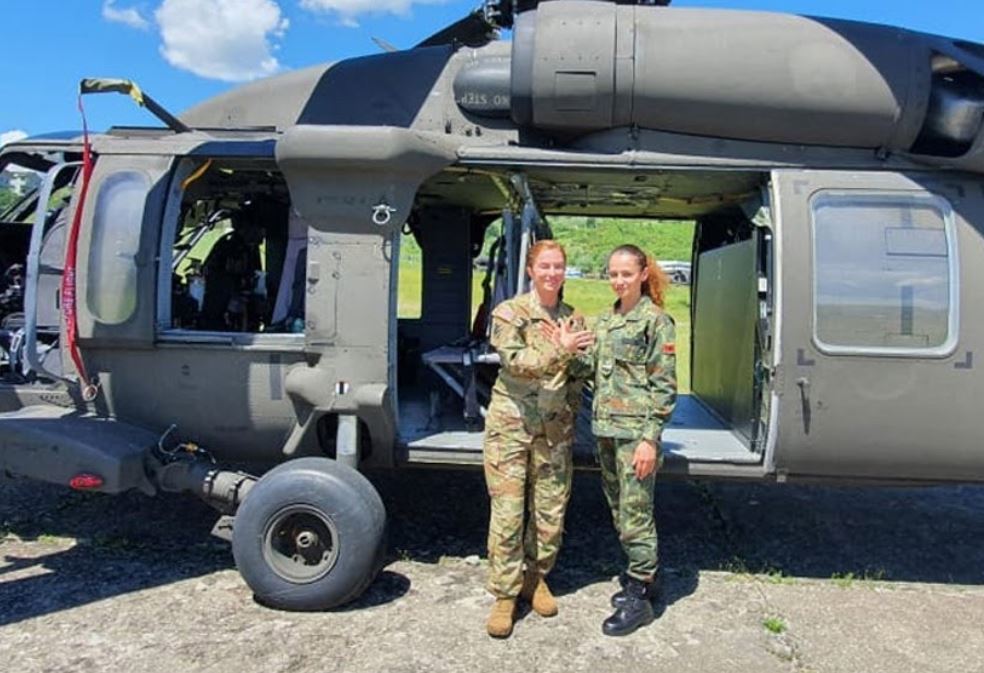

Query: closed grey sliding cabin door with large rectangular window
[[773, 171, 984, 480]]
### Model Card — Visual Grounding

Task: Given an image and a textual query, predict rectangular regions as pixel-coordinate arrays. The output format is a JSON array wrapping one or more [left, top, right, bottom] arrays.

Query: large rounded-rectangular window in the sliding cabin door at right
[[811, 192, 957, 355]]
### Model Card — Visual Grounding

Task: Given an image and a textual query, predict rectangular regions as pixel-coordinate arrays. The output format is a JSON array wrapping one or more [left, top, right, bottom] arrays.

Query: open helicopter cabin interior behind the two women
[[397, 165, 773, 471]]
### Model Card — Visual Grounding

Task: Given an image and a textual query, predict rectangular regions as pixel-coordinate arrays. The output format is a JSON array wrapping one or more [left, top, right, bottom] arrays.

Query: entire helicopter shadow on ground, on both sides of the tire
[[0, 470, 984, 625]]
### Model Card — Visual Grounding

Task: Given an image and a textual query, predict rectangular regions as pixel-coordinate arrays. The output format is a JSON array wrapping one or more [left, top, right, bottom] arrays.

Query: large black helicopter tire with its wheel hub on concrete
[[232, 458, 386, 611]]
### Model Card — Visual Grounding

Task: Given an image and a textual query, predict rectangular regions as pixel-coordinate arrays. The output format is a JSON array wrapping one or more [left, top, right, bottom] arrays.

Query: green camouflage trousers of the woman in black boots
[[597, 437, 659, 582]]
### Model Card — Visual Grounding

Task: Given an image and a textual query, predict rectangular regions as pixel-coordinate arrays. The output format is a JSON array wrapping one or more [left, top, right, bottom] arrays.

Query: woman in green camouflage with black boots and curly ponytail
[[551, 245, 677, 636]]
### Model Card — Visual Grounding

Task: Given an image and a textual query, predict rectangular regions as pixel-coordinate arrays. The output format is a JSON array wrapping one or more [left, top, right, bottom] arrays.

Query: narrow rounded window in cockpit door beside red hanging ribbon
[[86, 171, 150, 325]]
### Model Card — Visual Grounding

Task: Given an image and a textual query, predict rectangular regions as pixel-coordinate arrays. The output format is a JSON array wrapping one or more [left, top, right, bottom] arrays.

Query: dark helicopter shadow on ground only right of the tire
[[373, 470, 984, 594]]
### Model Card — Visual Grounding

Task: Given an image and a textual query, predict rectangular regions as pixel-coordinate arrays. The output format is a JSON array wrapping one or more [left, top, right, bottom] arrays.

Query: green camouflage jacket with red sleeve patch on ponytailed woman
[[569, 295, 677, 442]]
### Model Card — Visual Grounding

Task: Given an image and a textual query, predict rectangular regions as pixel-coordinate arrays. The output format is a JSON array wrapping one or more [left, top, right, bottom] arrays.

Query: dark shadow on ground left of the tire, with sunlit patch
[[0, 482, 233, 625]]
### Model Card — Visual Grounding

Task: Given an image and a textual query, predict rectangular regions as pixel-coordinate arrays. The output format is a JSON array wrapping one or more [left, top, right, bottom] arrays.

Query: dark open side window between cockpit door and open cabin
[[165, 158, 294, 333]]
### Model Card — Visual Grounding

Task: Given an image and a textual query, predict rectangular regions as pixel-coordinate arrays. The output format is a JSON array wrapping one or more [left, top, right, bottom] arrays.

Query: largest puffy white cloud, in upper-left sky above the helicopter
[[155, 0, 288, 82]]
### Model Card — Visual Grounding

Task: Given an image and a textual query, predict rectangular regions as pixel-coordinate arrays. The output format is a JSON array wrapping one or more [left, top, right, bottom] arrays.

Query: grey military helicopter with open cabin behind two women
[[0, 0, 984, 610]]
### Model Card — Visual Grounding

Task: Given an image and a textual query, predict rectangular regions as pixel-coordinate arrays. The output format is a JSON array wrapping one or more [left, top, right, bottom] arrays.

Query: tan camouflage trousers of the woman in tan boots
[[484, 421, 573, 598]]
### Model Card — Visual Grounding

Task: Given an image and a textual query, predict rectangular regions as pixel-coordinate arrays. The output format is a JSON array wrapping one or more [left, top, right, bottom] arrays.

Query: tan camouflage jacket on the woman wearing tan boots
[[490, 292, 581, 422]]
